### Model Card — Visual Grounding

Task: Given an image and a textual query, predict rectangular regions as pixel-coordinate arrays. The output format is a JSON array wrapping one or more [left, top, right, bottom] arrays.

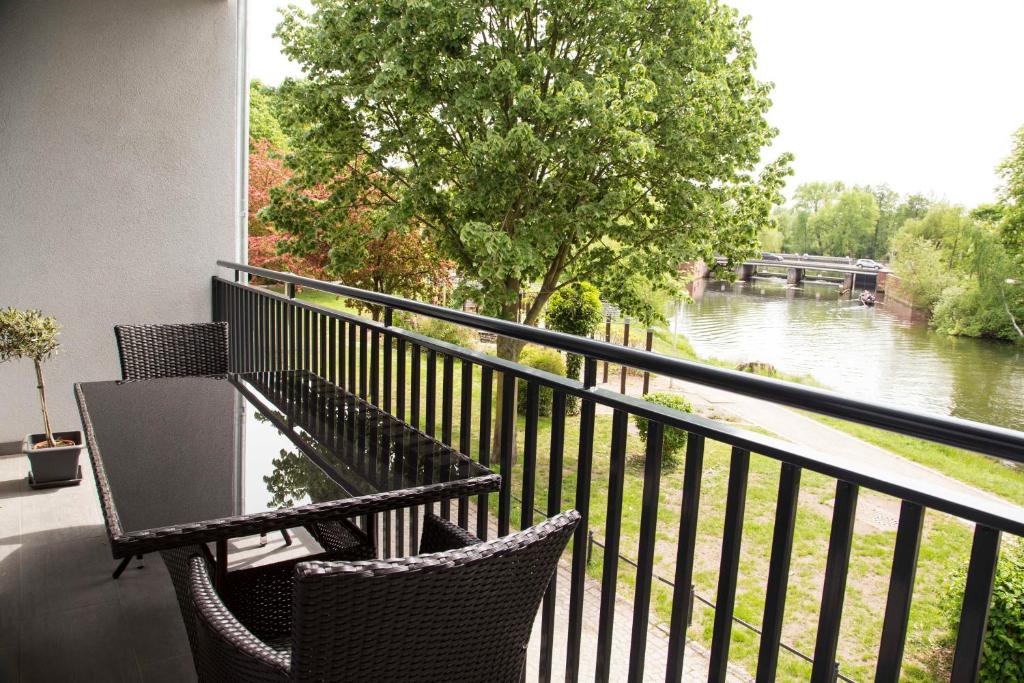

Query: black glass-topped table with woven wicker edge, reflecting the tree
[[75, 371, 501, 565]]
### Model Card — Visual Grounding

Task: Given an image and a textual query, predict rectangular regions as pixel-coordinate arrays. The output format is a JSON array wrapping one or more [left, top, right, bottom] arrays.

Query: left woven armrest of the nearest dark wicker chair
[[188, 557, 291, 681]]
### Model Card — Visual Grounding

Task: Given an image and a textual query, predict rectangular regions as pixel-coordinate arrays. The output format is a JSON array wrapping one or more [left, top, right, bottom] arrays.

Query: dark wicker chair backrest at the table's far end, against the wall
[[114, 323, 227, 380]]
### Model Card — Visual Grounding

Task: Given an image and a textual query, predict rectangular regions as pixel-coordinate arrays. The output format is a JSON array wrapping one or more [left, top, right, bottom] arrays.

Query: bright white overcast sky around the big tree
[[248, 0, 1024, 206]]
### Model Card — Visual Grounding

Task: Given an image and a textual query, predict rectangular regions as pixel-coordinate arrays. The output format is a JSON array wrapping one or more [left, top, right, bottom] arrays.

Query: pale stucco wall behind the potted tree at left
[[0, 0, 244, 453]]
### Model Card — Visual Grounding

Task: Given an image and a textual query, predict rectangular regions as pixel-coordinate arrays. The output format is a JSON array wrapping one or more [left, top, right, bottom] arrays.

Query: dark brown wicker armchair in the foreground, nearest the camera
[[163, 510, 580, 683]]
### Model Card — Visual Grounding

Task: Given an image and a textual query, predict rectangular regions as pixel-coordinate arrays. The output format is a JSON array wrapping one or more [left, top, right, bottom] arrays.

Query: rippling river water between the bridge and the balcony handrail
[[670, 279, 1024, 430]]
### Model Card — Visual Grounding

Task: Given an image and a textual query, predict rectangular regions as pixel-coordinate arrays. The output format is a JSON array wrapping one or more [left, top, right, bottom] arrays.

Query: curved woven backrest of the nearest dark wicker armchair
[[291, 510, 580, 683]]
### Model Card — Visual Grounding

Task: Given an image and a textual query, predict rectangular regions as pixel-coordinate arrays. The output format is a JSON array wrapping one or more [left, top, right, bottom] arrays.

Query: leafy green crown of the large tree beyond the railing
[[274, 0, 790, 339]]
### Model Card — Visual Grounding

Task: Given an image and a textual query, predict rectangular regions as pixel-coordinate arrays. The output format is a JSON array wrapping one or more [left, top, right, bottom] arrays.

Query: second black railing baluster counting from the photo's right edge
[[874, 501, 925, 683]]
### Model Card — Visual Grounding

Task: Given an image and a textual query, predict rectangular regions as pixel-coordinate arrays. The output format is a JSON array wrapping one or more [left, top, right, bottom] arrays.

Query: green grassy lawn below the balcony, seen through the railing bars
[[288, 292, 983, 681]]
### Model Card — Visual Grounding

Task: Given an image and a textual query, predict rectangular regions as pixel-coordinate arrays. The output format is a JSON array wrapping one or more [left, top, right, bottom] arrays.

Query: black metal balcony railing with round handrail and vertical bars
[[213, 261, 1024, 681]]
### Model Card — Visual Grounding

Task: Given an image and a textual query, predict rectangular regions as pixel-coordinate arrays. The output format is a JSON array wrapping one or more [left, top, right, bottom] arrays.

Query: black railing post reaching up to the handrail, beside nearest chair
[[565, 357, 597, 683]]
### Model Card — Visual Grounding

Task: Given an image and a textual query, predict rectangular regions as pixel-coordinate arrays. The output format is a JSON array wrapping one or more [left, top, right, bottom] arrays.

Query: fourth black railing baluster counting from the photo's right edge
[[758, 463, 801, 681]]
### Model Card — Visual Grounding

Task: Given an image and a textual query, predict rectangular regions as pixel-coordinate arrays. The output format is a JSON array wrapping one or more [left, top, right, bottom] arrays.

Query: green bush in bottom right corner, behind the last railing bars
[[941, 543, 1024, 683]]
